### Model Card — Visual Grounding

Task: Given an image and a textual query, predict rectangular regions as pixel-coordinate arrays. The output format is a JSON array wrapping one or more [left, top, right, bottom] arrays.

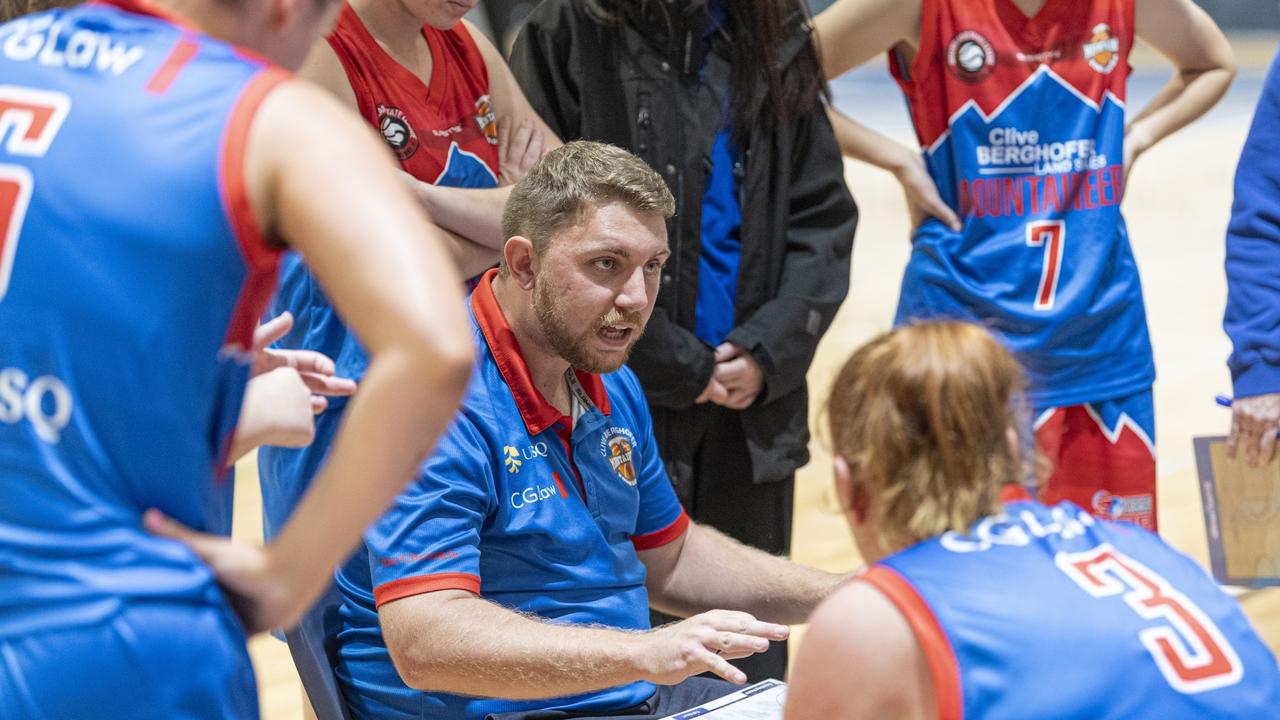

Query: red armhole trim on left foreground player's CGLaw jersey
[[219, 67, 292, 350]]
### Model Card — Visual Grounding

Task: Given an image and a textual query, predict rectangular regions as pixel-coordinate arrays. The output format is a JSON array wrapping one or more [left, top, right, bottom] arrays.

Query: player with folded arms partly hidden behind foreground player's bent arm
[[259, 0, 559, 537]]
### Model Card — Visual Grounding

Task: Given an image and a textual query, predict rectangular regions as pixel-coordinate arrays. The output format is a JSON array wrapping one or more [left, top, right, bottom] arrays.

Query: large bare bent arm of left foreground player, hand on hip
[[147, 82, 472, 632]]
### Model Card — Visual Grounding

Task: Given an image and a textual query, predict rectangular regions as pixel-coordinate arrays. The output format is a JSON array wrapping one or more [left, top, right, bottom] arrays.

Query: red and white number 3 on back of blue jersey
[[1055, 544, 1244, 694]]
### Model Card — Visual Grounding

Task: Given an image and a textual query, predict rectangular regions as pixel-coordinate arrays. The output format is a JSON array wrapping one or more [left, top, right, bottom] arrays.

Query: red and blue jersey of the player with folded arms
[[259, 4, 499, 537]]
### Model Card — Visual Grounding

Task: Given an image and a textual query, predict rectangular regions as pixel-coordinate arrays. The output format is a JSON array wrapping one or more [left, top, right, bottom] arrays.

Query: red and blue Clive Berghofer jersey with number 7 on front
[[890, 0, 1155, 407]]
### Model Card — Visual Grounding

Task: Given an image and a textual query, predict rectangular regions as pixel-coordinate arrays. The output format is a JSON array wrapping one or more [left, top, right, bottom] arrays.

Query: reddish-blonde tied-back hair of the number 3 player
[[826, 322, 1030, 543]]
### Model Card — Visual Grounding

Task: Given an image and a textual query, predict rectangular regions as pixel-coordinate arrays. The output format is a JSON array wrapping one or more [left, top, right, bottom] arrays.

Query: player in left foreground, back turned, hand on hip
[[0, 0, 471, 707]]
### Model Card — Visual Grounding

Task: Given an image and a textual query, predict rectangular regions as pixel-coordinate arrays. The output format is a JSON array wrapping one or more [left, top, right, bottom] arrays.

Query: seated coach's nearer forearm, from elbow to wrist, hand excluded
[[379, 591, 645, 700]]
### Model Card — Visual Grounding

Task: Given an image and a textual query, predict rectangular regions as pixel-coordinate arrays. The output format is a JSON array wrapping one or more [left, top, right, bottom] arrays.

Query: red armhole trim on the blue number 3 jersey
[[856, 565, 964, 720]]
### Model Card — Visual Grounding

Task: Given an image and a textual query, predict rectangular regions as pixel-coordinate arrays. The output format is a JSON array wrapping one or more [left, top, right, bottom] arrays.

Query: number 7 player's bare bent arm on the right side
[[1125, 0, 1235, 169]]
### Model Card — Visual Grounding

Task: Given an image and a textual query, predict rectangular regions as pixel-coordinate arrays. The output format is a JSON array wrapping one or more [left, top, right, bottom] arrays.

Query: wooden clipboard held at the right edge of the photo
[[1193, 436, 1280, 588]]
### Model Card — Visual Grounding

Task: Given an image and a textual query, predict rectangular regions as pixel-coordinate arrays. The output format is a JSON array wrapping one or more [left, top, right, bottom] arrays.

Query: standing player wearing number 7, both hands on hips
[[815, 0, 1234, 528]]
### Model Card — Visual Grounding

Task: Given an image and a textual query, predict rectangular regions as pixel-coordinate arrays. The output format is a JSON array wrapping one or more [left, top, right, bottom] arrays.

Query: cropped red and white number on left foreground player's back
[[0, 85, 72, 300]]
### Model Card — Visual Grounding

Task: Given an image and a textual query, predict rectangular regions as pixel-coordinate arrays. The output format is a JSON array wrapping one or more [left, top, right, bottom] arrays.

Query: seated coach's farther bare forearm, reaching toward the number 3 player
[[640, 523, 845, 625]]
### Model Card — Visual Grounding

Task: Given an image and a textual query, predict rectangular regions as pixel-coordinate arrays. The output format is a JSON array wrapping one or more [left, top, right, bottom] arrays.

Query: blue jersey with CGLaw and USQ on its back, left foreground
[[0, 0, 287, 638]]
